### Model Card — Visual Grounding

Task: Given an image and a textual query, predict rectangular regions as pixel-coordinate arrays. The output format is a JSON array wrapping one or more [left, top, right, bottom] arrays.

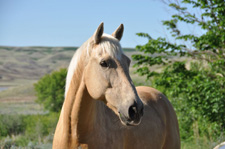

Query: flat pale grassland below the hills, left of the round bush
[[0, 80, 45, 115]]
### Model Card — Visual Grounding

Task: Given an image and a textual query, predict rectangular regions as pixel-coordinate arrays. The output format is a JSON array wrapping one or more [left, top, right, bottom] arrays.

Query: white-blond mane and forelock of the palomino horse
[[65, 34, 123, 96]]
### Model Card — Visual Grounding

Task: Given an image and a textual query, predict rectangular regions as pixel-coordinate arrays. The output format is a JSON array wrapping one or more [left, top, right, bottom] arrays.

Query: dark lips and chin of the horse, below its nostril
[[119, 113, 141, 126]]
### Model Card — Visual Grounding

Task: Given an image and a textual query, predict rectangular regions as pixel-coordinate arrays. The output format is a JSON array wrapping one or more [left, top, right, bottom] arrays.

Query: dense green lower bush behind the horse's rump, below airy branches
[[153, 62, 225, 140]]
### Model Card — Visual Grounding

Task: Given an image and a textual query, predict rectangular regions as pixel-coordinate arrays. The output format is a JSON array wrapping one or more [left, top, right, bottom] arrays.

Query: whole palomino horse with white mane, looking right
[[53, 23, 180, 149]]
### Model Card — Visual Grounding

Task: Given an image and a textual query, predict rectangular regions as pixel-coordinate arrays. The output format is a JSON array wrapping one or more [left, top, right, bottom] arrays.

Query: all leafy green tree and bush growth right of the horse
[[132, 0, 225, 142]]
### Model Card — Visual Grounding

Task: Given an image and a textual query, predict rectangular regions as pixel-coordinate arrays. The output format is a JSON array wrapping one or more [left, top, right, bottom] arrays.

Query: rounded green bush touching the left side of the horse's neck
[[34, 69, 67, 112]]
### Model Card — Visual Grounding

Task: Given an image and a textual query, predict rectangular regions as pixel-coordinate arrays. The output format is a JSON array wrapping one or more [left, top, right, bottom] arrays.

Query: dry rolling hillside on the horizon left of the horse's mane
[[0, 47, 77, 86]]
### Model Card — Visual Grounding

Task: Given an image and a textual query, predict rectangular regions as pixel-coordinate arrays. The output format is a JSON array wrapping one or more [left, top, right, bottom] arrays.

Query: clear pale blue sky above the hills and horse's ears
[[0, 0, 191, 48]]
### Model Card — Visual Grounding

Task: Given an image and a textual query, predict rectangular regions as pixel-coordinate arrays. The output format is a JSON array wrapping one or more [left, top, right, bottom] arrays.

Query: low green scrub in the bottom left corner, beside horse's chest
[[0, 113, 59, 148]]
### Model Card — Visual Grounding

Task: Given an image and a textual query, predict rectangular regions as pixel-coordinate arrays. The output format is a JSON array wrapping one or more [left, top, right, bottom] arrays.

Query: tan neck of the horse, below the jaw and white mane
[[53, 74, 95, 148]]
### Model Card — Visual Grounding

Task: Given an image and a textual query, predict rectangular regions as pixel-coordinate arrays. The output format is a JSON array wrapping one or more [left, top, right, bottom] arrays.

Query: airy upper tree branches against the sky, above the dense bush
[[132, 0, 225, 78]]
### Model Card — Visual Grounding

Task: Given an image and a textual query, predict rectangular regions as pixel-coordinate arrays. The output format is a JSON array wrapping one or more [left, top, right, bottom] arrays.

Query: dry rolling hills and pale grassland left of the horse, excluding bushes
[[0, 47, 76, 118]]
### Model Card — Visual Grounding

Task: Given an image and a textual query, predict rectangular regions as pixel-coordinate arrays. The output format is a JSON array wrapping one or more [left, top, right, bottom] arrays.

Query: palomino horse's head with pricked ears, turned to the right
[[83, 23, 143, 126]]
